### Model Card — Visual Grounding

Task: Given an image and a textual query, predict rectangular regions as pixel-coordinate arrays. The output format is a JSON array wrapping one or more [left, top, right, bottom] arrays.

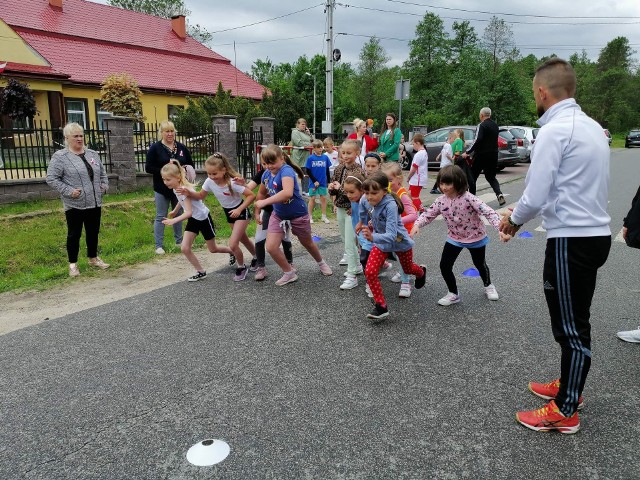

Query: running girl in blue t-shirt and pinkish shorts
[[255, 144, 333, 286]]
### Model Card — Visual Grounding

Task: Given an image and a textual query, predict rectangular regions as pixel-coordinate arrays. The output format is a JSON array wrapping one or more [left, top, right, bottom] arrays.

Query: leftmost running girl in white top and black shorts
[[160, 159, 231, 282]]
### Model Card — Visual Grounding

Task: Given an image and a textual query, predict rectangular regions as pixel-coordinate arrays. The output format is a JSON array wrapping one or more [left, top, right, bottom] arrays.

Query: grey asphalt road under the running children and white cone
[[0, 150, 640, 479]]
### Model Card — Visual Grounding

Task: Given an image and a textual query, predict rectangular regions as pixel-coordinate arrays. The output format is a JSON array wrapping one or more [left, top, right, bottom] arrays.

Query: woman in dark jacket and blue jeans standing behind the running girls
[[144, 120, 193, 255]]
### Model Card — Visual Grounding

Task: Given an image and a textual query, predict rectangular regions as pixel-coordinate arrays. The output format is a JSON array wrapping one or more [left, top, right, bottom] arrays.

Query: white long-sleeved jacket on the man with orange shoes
[[511, 98, 611, 238]]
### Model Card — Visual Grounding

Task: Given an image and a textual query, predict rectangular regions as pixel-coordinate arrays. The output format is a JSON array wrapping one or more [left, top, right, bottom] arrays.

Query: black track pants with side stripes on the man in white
[[543, 235, 611, 416]]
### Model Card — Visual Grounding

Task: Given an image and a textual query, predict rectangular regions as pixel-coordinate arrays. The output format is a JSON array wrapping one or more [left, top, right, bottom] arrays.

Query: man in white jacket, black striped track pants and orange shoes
[[500, 58, 611, 433]]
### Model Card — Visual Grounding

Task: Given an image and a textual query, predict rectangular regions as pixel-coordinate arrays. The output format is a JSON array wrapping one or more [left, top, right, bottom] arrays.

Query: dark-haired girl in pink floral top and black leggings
[[411, 165, 511, 307]]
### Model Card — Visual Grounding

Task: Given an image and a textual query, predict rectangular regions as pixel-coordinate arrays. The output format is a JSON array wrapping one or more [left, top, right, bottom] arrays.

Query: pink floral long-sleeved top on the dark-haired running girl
[[416, 192, 500, 243]]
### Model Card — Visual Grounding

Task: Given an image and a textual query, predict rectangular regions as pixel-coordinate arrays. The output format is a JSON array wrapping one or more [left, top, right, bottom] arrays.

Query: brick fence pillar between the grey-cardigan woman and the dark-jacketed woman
[[104, 117, 137, 192]]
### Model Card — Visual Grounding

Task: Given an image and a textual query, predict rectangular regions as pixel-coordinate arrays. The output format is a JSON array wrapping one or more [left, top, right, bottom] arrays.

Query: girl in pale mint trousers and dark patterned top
[[329, 139, 364, 290]]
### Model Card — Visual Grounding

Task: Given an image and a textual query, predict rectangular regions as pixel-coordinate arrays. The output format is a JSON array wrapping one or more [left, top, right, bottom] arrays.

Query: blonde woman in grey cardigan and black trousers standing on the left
[[47, 123, 109, 277]]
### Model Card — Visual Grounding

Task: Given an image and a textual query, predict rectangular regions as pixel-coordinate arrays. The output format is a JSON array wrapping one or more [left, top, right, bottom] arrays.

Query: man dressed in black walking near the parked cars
[[462, 107, 506, 205]]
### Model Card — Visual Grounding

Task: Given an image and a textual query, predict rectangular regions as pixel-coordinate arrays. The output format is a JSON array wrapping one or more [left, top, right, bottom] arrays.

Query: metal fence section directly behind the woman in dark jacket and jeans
[[133, 123, 220, 172]]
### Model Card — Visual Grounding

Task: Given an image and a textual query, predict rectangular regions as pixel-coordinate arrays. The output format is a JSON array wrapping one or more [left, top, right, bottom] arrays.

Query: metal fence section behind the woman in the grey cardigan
[[0, 122, 111, 180]]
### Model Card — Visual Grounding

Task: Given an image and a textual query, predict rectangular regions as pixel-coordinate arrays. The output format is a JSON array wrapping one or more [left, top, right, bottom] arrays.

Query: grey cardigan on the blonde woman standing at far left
[[47, 148, 109, 211]]
